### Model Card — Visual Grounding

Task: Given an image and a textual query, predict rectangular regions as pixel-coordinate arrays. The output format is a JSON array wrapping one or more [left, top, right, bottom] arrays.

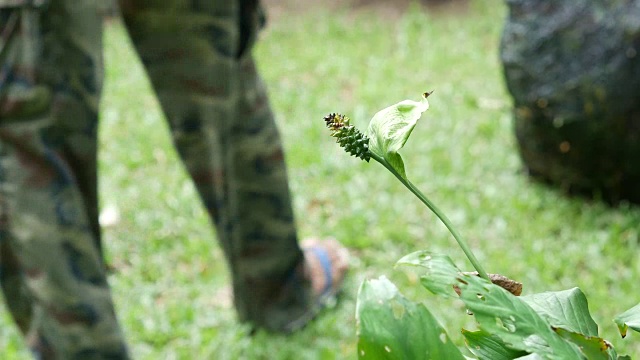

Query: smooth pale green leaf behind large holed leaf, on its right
[[521, 288, 598, 336]]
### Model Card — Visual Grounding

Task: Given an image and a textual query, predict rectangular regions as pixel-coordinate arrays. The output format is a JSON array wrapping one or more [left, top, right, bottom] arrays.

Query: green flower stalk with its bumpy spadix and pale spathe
[[324, 92, 491, 281]]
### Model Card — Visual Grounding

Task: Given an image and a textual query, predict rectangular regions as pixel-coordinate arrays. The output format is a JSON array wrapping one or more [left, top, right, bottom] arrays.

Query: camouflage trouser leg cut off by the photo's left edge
[[0, 0, 127, 359]]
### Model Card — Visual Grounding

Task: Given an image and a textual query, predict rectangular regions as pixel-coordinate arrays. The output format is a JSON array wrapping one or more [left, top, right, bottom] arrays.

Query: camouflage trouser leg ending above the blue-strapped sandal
[[116, 0, 344, 331]]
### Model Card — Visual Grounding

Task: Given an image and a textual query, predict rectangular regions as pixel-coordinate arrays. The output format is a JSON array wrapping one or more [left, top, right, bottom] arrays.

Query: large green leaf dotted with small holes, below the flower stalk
[[401, 253, 584, 359]]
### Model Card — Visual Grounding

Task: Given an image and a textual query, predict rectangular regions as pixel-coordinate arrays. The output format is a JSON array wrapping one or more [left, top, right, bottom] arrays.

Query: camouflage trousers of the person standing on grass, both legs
[[0, 0, 310, 359]]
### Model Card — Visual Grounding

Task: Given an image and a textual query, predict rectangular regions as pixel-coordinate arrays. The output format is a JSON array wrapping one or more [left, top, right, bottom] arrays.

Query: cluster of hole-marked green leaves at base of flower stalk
[[357, 251, 640, 360]]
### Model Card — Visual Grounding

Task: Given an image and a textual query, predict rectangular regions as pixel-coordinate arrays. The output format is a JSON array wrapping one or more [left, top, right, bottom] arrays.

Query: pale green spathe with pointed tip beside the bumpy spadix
[[367, 97, 429, 179]]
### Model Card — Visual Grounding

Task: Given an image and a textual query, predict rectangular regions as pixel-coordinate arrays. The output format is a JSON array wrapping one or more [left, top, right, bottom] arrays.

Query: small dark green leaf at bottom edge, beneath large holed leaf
[[462, 329, 528, 360]]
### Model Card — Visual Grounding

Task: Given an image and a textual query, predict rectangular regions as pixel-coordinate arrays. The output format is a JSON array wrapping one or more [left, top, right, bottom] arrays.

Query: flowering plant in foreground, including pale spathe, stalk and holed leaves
[[324, 93, 640, 360]]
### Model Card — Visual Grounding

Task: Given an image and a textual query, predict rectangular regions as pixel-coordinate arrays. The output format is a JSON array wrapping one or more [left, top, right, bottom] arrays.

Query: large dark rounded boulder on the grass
[[501, 0, 640, 203]]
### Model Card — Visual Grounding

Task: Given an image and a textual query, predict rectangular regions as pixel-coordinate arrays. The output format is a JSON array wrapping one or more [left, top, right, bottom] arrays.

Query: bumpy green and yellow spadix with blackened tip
[[324, 113, 371, 162]]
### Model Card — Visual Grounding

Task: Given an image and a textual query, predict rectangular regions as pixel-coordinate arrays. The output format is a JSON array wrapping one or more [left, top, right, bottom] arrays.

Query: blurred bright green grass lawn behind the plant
[[0, 0, 640, 359]]
